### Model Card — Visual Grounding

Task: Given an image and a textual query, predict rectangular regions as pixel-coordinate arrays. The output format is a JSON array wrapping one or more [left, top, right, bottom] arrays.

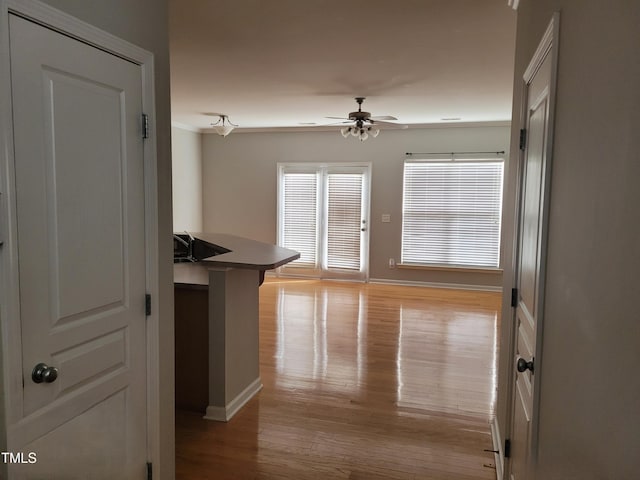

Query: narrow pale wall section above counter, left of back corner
[[171, 127, 202, 232]]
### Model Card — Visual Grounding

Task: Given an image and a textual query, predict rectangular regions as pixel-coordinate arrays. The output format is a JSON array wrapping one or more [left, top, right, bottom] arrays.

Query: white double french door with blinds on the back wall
[[278, 163, 371, 280]]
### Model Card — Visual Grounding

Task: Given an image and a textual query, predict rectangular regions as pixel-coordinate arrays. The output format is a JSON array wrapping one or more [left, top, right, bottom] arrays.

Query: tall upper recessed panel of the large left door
[[45, 71, 127, 325]]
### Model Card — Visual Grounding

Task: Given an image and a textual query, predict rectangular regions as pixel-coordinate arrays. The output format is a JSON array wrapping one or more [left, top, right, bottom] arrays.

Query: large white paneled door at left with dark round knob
[[7, 15, 147, 479]]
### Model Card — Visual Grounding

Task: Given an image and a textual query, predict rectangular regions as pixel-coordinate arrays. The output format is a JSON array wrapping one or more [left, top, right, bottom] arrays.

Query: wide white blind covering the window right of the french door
[[402, 160, 504, 267]]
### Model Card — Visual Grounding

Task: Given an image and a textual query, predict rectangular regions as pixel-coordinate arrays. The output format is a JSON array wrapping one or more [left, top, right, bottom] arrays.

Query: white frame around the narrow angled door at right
[[504, 12, 560, 478]]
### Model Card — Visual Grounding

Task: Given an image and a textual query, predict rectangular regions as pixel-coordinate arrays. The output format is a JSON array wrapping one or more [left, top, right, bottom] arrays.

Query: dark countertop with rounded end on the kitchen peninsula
[[173, 232, 300, 286]]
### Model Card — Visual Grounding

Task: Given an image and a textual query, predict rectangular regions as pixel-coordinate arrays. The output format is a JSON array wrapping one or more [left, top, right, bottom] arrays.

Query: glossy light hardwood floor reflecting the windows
[[176, 279, 500, 480]]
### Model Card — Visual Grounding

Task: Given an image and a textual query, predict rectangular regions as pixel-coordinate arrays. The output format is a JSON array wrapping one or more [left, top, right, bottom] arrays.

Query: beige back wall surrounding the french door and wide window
[[202, 126, 510, 287]]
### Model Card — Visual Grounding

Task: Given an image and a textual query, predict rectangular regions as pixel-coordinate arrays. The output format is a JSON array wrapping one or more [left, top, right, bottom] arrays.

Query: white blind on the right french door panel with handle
[[327, 173, 364, 271]]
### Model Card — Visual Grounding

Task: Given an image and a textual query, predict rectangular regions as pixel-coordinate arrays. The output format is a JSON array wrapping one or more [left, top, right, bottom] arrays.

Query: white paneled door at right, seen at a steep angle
[[510, 18, 553, 480]]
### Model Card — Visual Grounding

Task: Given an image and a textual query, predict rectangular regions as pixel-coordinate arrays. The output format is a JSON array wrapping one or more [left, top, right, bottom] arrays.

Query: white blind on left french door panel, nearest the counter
[[281, 172, 318, 268]]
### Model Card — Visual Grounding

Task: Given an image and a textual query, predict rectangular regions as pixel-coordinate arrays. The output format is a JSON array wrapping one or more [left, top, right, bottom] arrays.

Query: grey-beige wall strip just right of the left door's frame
[[35, 0, 175, 480]]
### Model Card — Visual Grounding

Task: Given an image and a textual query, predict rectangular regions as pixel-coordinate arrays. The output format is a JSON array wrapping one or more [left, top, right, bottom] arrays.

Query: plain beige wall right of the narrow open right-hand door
[[499, 0, 640, 480]]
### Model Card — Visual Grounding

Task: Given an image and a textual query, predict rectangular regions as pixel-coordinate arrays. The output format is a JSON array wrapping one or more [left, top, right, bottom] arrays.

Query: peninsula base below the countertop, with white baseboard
[[175, 268, 262, 421]]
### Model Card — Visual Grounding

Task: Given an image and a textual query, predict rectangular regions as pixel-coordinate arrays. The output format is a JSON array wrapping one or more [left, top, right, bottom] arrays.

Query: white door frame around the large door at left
[[0, 0, 162, 478]]
